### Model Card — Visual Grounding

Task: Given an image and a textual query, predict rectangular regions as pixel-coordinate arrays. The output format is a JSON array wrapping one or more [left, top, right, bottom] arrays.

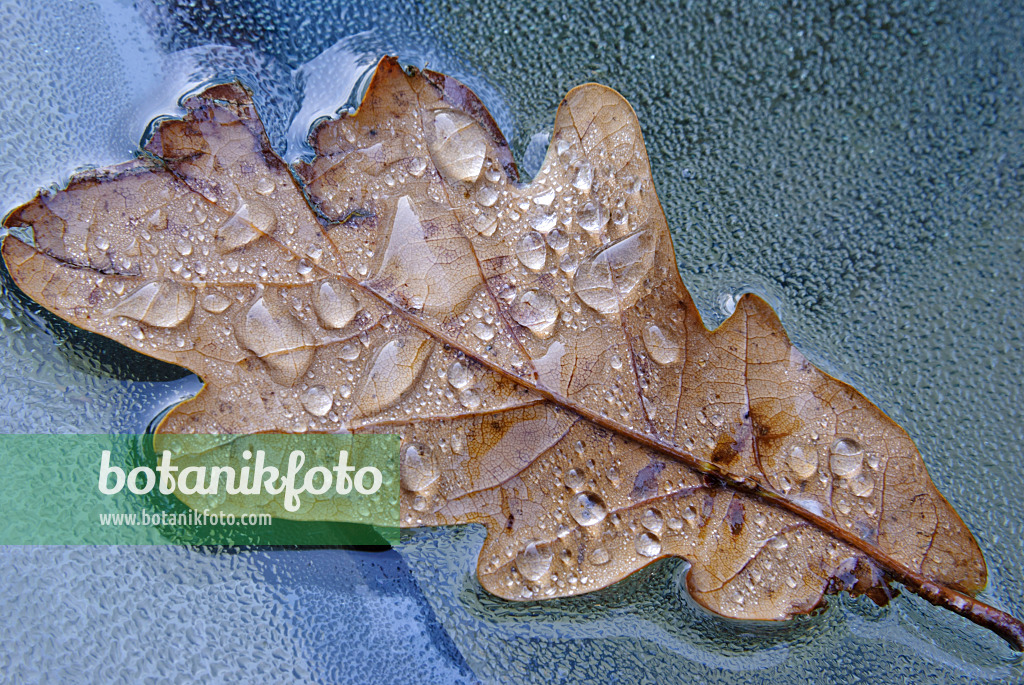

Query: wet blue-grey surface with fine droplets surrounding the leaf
[[0, 0, 1024, 683]]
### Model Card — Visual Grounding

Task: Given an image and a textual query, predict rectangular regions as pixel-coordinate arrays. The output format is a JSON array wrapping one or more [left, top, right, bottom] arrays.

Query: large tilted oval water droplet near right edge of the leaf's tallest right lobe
[[572, 230, 654, 314]]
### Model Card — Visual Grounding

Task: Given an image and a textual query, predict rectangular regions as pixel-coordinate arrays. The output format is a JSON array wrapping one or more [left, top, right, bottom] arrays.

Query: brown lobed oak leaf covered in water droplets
[[3, 58, 1024, 648]]
